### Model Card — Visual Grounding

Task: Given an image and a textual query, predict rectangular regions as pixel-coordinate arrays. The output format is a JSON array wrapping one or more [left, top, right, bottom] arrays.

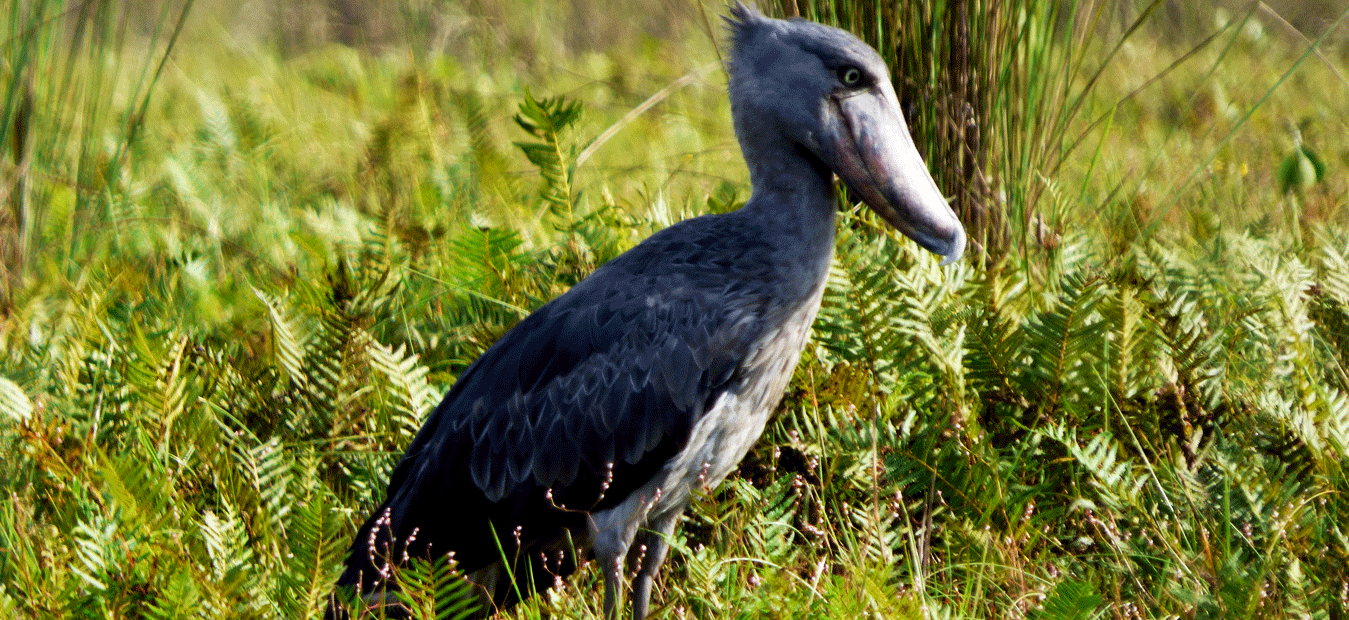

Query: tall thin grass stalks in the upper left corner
[[0, 0, 192, 301]]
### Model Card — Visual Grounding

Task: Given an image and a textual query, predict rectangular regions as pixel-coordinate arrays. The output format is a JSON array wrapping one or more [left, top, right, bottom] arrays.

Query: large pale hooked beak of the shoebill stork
[[830, 82, 965, 264]]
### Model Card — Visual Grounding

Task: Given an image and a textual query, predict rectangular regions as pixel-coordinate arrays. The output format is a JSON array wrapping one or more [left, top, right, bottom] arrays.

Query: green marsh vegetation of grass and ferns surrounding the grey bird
[[0, 0, 1349, 619]]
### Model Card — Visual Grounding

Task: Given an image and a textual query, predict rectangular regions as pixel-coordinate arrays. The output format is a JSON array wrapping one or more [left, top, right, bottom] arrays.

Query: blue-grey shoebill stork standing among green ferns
[[331, 3, 965, 619]]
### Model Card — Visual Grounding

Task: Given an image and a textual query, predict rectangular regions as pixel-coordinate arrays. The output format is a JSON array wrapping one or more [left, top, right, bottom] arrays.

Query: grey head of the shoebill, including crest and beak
[[727, 3, 965, 264]]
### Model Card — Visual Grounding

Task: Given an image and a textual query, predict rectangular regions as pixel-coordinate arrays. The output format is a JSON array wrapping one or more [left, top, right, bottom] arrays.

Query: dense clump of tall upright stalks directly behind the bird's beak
[[787, 0, 1100, 260]]
